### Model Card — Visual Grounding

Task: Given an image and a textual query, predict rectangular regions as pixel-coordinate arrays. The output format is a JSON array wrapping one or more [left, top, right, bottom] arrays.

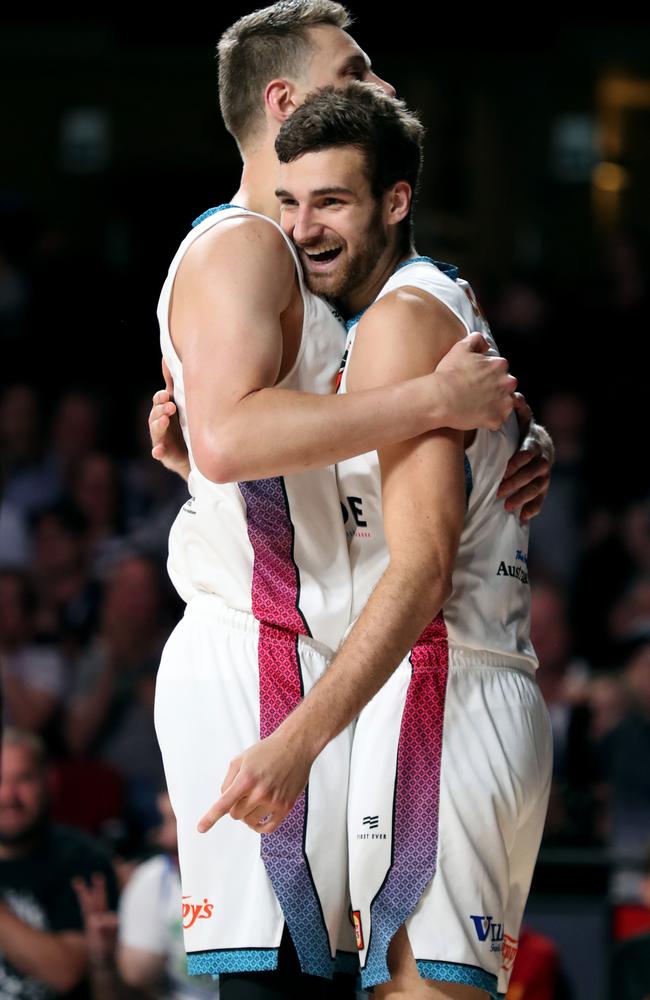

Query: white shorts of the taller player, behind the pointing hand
[[155, 594, 356, 977]]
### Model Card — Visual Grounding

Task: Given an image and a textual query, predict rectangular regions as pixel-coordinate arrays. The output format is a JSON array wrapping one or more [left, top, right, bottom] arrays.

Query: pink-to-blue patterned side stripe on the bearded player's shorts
[[361, 613, 448, 988]]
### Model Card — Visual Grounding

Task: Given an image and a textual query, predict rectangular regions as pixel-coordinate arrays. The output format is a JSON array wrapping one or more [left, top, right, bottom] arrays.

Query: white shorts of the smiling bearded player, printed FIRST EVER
[[348, 623, 552, 998]]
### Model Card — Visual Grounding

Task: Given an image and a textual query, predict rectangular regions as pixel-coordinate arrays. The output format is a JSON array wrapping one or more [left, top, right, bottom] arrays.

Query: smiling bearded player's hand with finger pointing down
[[198, 729, 313, 833]]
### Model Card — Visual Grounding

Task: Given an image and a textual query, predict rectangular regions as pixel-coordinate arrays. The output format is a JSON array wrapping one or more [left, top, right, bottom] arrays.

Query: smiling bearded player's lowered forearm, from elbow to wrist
[[281, 565, 449, 757]]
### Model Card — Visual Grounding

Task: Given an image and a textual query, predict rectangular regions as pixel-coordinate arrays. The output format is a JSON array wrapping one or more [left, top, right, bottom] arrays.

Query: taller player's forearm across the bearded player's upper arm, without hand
[[195, 376, 451, 482]]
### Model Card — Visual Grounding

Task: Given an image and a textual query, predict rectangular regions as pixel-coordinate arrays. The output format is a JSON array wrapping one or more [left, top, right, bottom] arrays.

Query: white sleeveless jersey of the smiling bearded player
[[337, 257, 537, 669]]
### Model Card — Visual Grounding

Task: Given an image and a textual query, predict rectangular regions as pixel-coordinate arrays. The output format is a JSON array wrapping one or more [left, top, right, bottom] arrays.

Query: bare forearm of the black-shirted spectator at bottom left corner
[[0, 904, 86, 993]]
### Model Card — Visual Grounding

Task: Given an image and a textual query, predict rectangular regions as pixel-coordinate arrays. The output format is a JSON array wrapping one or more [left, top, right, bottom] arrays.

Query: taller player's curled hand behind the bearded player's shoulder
[[434, 333, 517, 431]]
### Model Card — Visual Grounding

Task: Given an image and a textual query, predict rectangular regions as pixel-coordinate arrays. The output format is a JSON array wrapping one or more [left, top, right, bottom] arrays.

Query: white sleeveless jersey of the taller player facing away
[[158, 205, 351, 649]]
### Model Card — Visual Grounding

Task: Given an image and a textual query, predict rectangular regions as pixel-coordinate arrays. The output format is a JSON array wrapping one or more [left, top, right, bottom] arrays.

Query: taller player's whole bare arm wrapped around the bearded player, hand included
[[170, 219, 513, 482]]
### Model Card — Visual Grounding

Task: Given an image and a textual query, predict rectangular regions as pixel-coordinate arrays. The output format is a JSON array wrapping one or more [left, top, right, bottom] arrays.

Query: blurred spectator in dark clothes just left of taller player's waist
[[64, 555, 167, 826]]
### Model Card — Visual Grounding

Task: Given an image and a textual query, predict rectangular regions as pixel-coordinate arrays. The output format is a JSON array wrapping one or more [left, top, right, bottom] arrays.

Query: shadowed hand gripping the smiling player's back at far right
[[497, 393, 554, 524]]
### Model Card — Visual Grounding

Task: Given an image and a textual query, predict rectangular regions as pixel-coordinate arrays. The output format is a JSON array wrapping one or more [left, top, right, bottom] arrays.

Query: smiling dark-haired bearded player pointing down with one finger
[[201, 83, 551, 1000]]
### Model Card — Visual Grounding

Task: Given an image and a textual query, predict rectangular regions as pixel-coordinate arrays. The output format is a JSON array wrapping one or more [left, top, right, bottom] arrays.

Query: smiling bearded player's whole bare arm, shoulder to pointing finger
[[200, 290, 465, 832]]
